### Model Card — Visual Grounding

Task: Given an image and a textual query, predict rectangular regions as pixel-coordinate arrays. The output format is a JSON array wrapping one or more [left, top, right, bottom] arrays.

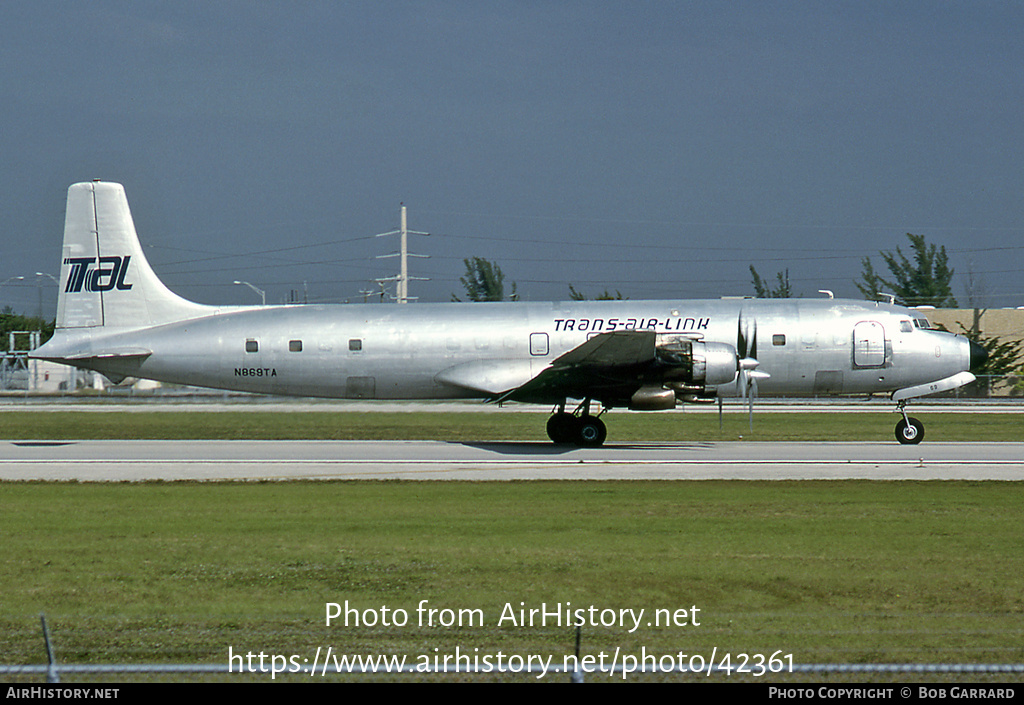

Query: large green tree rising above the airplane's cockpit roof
[[857, 233, 956, 308]]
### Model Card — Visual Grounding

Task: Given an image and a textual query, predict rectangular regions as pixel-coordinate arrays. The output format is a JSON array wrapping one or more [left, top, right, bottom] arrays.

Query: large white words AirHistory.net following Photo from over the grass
[[498, 603, 700, 633]]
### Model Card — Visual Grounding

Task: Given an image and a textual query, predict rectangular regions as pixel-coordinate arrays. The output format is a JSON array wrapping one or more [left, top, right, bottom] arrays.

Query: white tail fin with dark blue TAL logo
[[56, 181, 211, 329]]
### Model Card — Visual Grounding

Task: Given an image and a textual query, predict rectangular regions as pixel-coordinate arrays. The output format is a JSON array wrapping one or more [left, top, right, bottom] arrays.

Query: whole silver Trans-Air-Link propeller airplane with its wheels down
[[32, 180, 986, 447]]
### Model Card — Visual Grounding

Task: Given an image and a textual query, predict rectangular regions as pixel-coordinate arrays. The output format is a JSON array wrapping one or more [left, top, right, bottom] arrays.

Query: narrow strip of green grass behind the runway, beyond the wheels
[[0, 411, 1024, 443]]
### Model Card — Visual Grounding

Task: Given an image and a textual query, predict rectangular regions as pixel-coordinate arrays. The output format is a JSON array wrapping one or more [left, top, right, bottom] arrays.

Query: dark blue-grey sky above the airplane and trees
[[0, 0, 1024, 318]]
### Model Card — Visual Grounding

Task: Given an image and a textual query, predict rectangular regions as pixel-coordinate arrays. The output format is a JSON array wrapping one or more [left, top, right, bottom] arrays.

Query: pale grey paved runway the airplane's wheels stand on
[[0, 441, 1024, 482]]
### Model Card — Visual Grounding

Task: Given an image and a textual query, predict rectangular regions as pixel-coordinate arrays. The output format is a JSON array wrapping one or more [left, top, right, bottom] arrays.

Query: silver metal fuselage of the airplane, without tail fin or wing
[[41, 299, 970, 400]]
